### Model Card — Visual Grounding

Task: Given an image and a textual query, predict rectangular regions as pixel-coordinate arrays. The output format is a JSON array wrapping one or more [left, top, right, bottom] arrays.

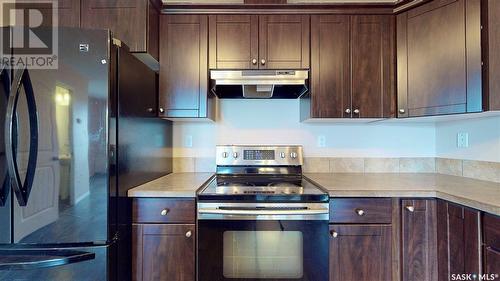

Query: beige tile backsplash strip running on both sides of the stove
[[173, 157, 500, 183]]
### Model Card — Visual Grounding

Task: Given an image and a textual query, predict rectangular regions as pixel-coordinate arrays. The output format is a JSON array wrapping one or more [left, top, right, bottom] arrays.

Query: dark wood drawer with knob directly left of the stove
[[132, 198, 196, 223]]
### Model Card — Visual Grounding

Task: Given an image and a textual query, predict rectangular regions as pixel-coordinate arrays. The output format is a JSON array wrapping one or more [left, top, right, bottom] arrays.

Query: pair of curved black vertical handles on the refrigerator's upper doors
[[5, 68, 38, 206]]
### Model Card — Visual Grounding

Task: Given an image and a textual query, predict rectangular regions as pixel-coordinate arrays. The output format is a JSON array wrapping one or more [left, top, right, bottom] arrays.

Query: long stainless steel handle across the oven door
[[198, 208, 329, 216]]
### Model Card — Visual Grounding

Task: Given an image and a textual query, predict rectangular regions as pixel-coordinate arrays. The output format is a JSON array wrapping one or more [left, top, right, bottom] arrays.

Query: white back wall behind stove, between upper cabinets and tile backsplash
[[173, 100, 436, 157]]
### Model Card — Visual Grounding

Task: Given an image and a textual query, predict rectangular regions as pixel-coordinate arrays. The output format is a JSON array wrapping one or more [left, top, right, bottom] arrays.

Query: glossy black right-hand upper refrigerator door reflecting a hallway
[[12, 28, 110, 244]]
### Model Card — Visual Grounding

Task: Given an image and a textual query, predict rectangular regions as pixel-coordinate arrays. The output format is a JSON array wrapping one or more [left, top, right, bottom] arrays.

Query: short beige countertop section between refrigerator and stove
[[127, 173, 214, 197]]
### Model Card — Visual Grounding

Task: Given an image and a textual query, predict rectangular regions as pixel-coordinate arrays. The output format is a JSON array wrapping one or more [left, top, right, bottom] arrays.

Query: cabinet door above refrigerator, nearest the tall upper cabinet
[[82, 0, 149, 52]]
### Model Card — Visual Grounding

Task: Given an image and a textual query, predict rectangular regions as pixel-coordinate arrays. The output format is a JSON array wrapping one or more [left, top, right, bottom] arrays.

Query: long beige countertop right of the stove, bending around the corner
[[305, 173, 500, 215]]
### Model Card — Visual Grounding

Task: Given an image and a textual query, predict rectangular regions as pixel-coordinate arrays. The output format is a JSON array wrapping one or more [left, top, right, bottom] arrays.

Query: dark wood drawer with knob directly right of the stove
[[330, 198, 392, 224]]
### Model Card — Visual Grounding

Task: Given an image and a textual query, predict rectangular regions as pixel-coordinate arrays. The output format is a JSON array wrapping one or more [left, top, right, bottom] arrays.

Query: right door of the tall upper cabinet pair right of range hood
[[351, 16, 395, 118]]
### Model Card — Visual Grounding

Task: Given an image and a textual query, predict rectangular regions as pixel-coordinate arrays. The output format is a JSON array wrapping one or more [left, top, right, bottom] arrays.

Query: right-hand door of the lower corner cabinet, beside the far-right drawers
[[437, 200, 481, 280]]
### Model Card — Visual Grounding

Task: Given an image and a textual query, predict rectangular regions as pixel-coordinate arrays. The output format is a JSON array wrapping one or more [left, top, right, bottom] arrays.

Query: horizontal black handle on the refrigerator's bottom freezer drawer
[[0, 249, 95, 270]]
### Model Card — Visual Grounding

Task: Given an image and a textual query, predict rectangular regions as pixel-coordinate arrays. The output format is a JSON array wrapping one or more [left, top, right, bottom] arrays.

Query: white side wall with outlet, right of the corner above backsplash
[[436, 116, 500, 162]]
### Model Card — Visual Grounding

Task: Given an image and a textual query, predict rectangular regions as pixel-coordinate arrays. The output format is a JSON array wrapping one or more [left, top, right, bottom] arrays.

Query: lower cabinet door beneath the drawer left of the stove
[[132, 224, 195, 281]]
